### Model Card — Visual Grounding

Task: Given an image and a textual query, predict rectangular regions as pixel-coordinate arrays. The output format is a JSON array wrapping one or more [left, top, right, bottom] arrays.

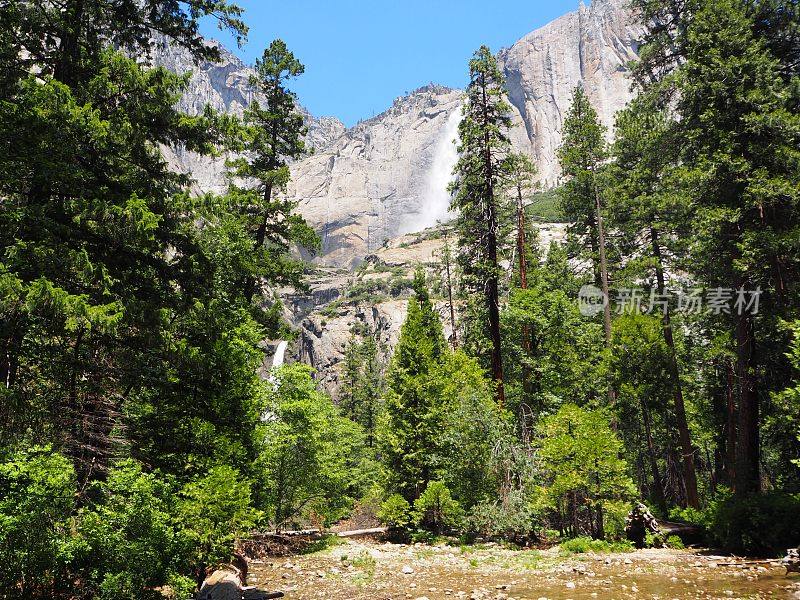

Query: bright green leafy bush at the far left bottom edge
[[0, 447, 78, 598]]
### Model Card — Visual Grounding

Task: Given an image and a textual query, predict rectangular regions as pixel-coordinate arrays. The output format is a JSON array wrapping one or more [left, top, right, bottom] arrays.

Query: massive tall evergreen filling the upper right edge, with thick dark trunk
[[638, 0, 800, 495]]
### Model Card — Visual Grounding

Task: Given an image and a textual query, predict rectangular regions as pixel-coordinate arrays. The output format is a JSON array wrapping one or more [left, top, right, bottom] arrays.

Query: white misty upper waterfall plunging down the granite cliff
[[400, 107, 461, 233]]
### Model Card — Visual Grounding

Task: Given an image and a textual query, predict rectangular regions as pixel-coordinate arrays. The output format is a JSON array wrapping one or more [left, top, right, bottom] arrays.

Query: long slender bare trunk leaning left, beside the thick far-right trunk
[[650, 227, 700, 508]]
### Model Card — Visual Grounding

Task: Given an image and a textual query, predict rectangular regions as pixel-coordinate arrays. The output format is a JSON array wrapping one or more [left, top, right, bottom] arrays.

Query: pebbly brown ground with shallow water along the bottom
[[251, 540, 800, 600]]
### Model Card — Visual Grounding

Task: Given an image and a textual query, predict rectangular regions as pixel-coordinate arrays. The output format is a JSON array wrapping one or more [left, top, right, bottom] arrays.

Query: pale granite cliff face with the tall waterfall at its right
[[288, 85, 462, 267]]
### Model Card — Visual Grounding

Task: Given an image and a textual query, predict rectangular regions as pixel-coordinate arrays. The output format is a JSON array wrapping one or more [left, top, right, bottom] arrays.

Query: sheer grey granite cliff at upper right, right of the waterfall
[[498, 0, 643, 185]]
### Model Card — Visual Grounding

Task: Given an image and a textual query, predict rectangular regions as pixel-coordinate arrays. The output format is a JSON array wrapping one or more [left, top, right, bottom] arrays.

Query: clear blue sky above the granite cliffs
[[198, 0, 588, 126]]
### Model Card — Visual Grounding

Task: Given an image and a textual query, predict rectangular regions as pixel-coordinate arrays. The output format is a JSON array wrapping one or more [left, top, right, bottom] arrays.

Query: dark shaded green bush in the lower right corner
[[708, 492, 800, 556]]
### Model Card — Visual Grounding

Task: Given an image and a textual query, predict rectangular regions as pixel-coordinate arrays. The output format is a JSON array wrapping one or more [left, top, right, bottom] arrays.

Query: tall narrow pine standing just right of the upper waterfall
[[452, 46, 511, 406]]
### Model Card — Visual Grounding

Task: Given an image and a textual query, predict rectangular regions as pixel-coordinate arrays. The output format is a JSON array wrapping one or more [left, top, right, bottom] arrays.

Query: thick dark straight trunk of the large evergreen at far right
[[734, 308, 761, 496]]
